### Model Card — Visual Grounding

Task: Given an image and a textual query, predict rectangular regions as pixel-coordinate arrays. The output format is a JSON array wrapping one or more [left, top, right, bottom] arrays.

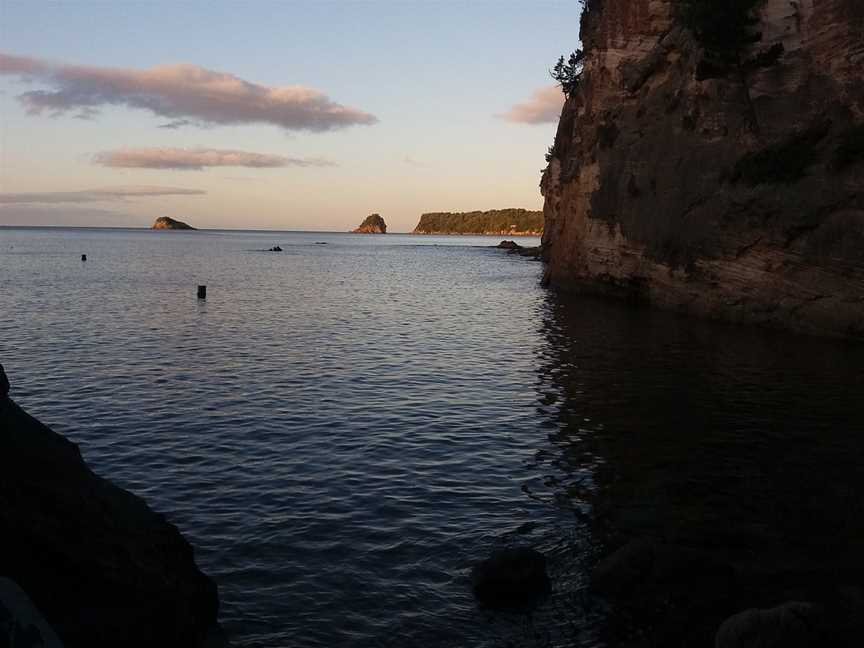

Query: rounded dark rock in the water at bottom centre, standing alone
[[471, 548, 551, 609]]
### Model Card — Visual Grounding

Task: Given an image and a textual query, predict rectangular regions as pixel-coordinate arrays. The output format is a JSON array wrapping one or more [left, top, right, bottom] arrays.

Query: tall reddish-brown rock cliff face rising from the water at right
[[541, 0, 864, 337]]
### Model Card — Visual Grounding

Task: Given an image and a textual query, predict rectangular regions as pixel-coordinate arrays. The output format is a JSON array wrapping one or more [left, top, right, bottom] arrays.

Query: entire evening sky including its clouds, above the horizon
[[0, 0, 579, 232]]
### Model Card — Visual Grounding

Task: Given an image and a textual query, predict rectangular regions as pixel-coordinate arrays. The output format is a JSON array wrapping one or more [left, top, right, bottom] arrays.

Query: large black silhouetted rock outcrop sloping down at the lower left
[[0, 367, 219, 648]]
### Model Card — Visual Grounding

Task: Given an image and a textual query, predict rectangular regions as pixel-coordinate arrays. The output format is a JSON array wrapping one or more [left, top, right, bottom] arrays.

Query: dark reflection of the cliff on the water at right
[[535, 293, 864, 644]]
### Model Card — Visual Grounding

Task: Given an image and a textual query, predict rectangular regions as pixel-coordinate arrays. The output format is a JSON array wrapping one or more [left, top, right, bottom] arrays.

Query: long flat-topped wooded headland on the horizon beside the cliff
[[412, 209, 543, 236]]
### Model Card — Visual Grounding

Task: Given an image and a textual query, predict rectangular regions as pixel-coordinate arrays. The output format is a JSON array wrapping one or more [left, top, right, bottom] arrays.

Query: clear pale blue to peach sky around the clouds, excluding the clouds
[[0, 0, 579, 231]]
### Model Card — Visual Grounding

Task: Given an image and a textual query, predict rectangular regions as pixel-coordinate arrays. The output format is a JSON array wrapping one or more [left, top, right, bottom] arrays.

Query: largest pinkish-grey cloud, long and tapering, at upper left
[[0, 53, 378, 132]]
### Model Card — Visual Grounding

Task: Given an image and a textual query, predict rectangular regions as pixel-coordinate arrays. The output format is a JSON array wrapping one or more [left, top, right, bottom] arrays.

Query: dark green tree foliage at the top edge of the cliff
[[678, 0, 762, 78]]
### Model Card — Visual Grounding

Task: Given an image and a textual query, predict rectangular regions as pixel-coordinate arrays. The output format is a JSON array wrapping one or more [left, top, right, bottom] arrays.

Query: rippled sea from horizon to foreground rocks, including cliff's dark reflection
[[0, 228, 864, 646]]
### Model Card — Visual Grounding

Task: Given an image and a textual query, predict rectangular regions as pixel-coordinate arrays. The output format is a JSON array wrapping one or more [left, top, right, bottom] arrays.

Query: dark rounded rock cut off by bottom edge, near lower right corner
[[714, 601, 824, 648]]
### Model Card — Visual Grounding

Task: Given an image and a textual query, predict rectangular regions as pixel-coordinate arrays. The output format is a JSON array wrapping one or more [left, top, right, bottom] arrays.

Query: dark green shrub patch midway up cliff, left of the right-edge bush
[[732, 121, 831, 187]]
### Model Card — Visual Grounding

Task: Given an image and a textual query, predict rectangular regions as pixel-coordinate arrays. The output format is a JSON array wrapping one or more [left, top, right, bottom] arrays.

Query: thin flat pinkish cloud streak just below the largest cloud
[[93, 148, 335, 171]]
